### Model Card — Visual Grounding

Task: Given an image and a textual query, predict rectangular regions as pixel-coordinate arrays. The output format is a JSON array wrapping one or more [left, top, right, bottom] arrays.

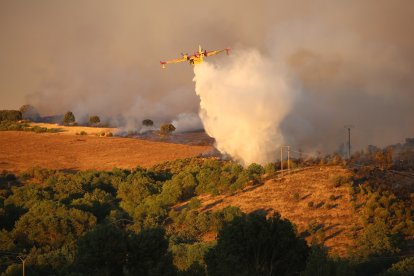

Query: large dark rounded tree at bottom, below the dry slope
[[206, 214, 309, 275]]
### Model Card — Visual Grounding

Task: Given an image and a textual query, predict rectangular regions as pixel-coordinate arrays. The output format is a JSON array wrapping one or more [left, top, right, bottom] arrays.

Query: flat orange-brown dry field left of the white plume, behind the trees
[[0, 130, 212, 172]]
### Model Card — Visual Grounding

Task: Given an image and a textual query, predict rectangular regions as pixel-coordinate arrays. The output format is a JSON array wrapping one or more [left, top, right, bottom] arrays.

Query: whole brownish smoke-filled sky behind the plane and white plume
[[0, 0, 414, 149]]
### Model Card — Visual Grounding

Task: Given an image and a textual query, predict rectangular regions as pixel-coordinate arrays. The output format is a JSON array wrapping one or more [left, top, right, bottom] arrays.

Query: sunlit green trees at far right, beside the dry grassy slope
[[340, 168, 414, 275]]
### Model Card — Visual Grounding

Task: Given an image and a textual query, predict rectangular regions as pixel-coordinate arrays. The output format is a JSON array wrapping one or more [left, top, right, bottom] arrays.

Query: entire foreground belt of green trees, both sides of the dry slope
[[0, 158, 413, 275]]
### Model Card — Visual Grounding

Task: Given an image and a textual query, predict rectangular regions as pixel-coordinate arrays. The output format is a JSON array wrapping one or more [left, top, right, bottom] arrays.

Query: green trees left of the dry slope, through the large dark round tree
[[0, 160, 309, 275]]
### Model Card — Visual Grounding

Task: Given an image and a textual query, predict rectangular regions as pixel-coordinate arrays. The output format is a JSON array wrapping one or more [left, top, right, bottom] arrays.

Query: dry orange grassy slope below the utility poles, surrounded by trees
[[194, 166, 360, 256]]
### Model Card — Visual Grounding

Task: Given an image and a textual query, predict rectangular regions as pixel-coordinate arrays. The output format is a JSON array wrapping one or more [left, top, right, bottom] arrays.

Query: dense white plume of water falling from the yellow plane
[[194, 50, 297, 165]]
